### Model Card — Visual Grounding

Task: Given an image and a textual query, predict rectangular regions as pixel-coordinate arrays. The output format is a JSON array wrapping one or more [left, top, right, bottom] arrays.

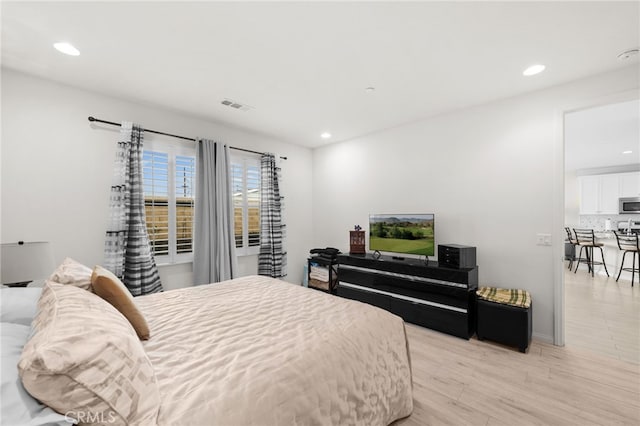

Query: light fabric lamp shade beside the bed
[[0, 242, 56, 284]]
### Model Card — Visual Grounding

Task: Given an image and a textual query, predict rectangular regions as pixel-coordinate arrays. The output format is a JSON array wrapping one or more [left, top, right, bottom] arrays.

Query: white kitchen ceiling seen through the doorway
[[565, 100, 640, 171]]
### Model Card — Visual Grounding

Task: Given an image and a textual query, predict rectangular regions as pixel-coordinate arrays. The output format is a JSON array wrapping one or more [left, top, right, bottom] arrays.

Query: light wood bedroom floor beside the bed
[[394, 324, 640, 426]]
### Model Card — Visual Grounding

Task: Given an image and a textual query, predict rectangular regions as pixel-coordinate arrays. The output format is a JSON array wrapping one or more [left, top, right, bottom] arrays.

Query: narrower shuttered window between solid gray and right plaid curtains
[[231, 155, 260, 256]]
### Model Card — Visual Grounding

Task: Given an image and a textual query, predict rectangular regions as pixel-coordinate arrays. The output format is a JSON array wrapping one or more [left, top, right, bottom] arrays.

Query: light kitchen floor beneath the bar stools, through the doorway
[[565, 266, 640, 364]]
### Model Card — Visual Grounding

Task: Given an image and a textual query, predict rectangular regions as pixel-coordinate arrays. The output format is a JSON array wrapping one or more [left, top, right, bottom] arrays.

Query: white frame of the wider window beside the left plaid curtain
[[143, 138, 197, 265]]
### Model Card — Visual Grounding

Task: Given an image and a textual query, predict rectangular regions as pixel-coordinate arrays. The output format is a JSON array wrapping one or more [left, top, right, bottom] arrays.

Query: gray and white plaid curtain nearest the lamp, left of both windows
[[104, 121, 162, 296]]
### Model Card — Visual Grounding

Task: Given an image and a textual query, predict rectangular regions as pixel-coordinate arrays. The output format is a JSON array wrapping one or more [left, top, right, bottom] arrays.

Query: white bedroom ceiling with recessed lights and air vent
[[2, 1, 640, 147]]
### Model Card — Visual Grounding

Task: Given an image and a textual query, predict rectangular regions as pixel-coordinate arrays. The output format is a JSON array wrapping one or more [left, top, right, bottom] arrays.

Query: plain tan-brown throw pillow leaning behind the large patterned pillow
[[91, 266, 150, 340]]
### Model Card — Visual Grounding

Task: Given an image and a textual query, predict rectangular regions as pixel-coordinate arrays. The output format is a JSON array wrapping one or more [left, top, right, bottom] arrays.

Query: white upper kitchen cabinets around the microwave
[[578, 172, 640, 215]]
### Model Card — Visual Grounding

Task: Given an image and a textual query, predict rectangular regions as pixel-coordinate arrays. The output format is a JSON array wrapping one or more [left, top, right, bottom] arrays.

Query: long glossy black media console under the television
[[337, 254, 478, 339]]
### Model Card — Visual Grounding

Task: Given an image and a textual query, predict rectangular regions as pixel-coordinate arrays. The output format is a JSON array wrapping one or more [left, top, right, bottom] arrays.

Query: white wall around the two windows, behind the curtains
[[0, 69, 312, 289]]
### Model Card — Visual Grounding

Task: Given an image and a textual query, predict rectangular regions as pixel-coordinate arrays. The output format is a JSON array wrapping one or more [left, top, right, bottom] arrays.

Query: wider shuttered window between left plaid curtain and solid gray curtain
[[142, 145, 196, 263]]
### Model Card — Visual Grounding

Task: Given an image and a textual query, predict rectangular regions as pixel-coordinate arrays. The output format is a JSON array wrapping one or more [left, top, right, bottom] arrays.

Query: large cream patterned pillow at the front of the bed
[[18, 281, 160, 425]]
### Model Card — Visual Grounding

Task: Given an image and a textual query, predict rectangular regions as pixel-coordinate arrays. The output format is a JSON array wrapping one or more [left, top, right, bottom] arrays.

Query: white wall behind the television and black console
[[313, 67, 639, 341]]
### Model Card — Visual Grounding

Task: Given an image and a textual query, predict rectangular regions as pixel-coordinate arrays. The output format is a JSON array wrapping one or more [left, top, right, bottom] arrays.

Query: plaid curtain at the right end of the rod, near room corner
[[258, 153, 287, 278]]
